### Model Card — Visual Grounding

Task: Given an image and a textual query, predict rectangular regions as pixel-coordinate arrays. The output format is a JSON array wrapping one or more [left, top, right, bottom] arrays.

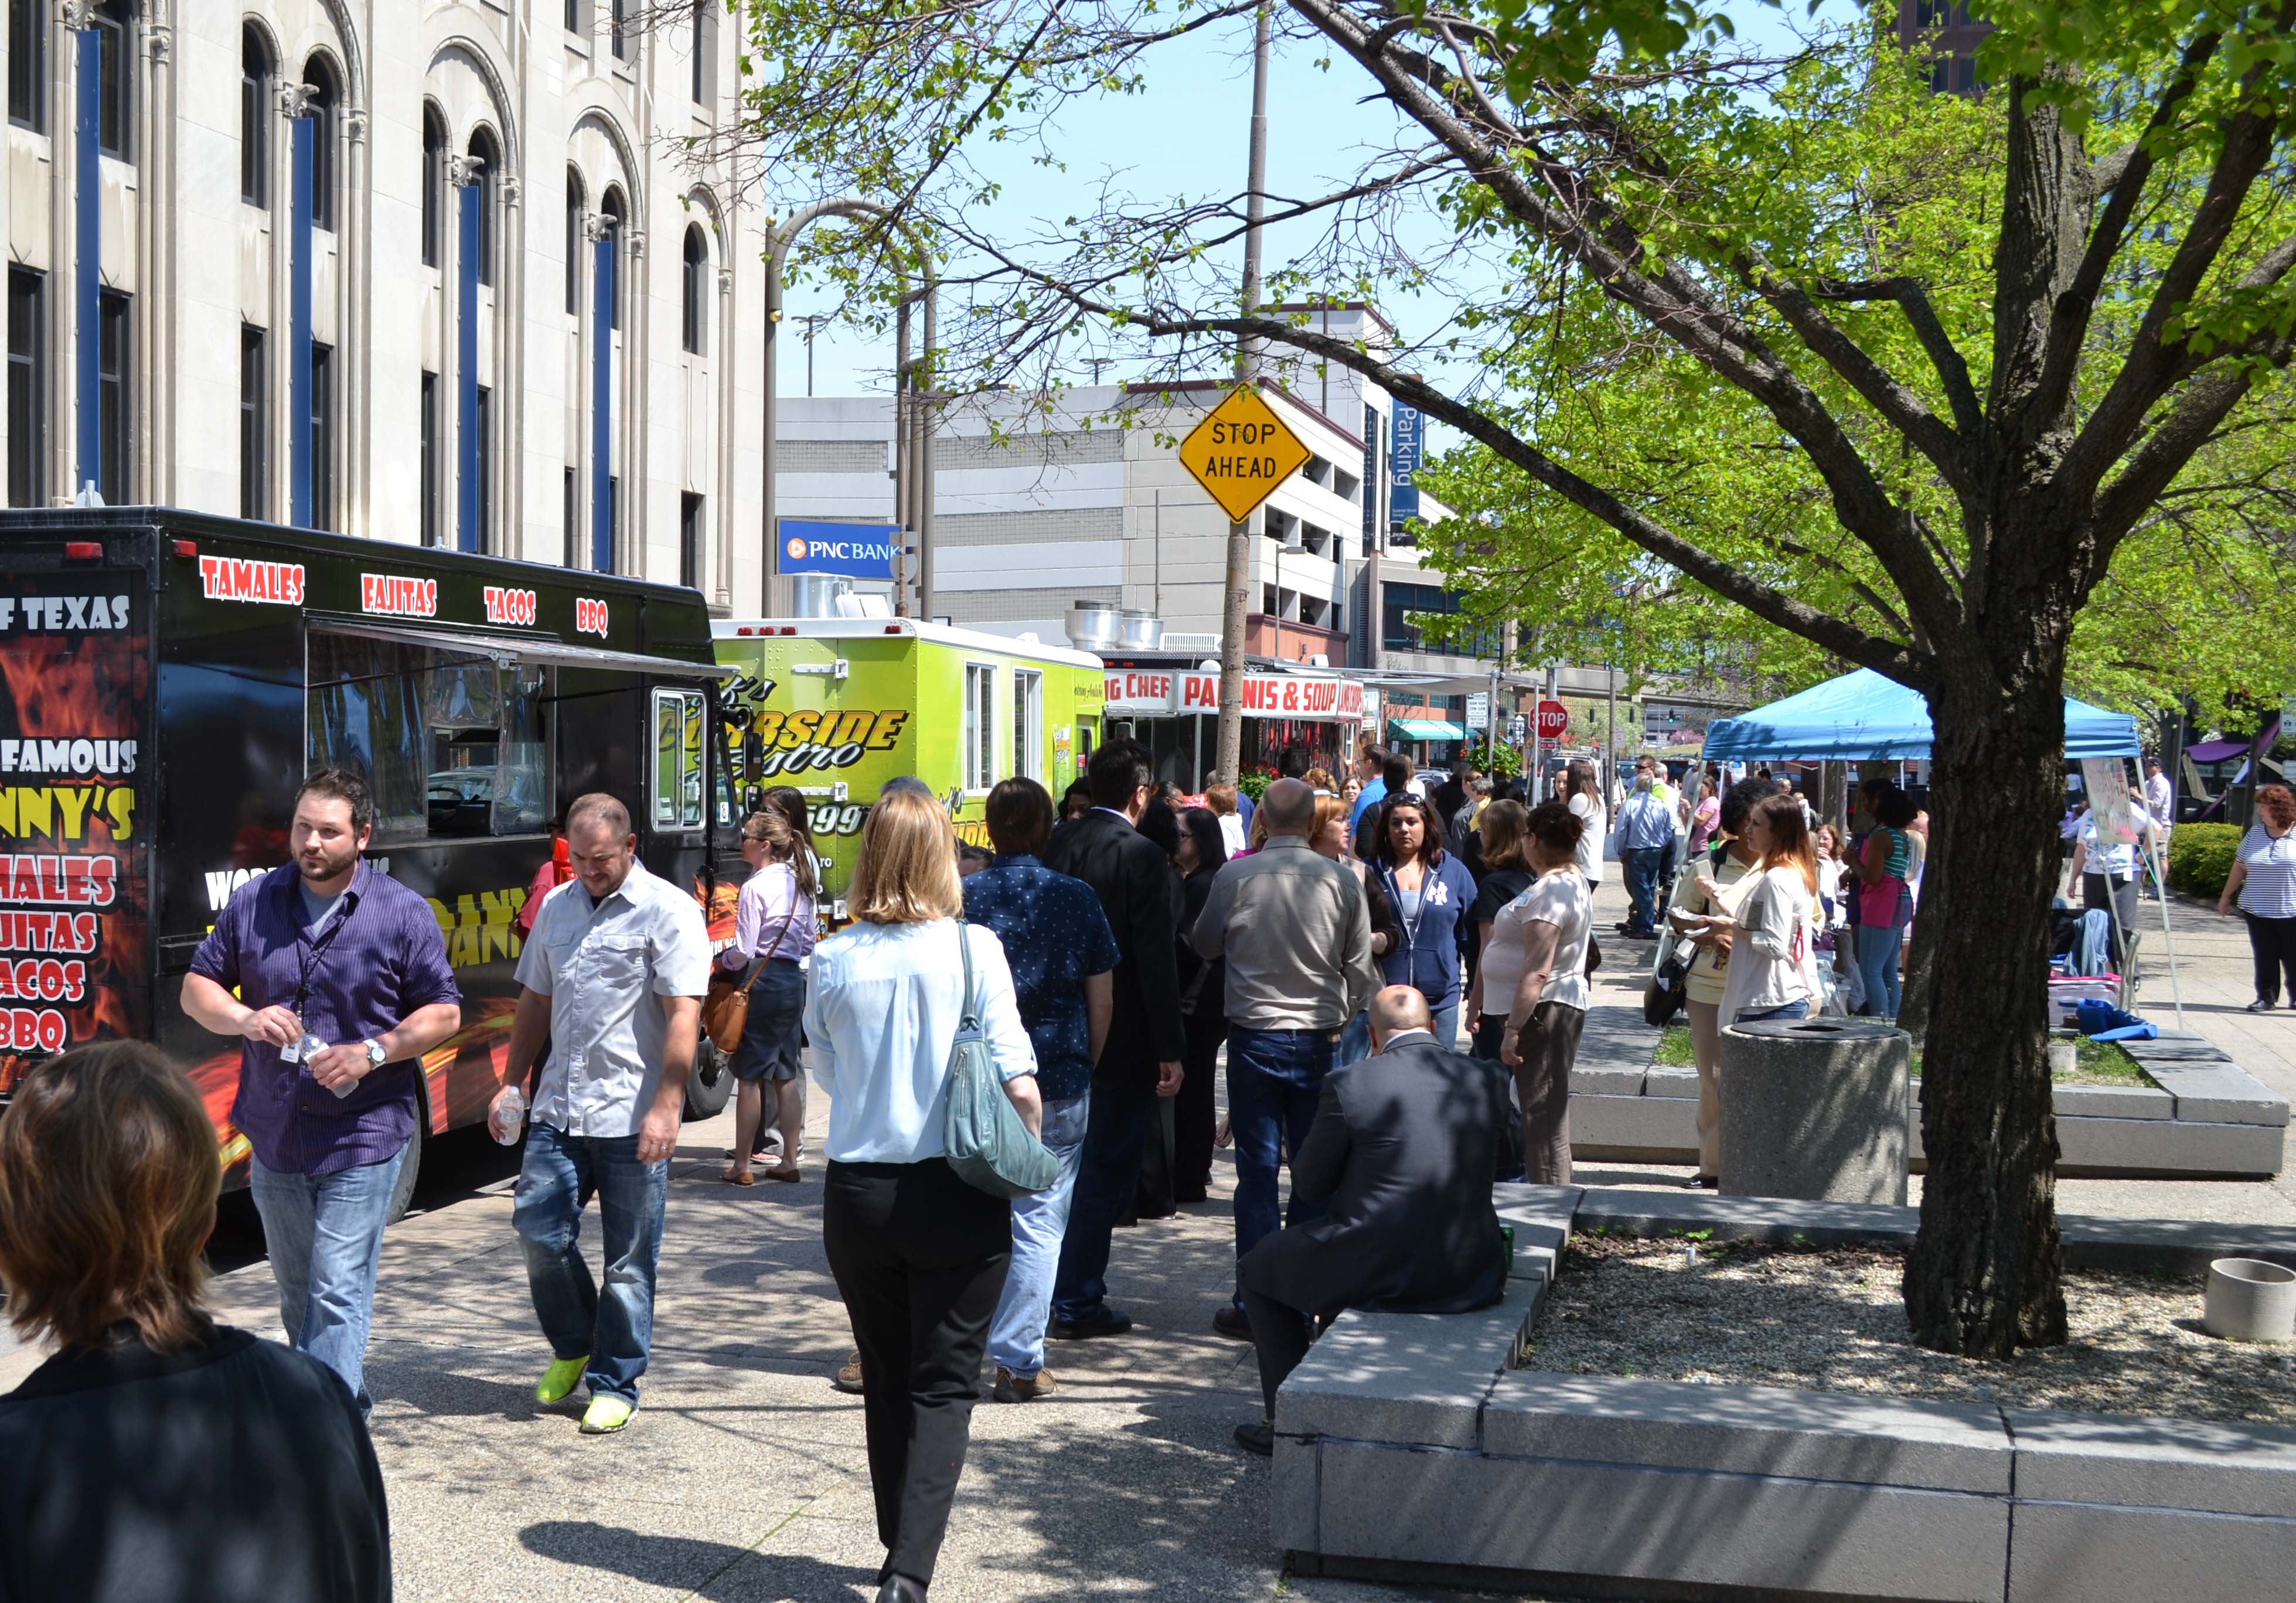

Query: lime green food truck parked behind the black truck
[[712, 618, 1105, 905]]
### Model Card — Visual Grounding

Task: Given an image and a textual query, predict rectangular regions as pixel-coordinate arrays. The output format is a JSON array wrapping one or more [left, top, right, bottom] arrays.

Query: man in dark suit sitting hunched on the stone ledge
[[1235, 985, 1513, 1456]]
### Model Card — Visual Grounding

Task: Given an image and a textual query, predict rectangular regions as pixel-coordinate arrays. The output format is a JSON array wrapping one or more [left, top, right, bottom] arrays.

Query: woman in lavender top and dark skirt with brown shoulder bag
[[718, 809, 820, 1185]]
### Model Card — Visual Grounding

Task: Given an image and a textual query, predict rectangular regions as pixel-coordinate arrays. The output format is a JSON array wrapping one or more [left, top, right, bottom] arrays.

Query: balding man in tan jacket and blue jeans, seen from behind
[[1190, 779, 1380, 1341]]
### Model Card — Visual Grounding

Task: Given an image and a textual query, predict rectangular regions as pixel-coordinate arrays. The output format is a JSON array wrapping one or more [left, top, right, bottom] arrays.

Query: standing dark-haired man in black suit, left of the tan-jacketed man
[[1043, 739, 1187, 1341]]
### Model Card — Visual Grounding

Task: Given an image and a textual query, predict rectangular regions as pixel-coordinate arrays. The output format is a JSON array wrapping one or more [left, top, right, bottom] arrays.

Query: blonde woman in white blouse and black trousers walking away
[[806, 790, 1043, 1603]]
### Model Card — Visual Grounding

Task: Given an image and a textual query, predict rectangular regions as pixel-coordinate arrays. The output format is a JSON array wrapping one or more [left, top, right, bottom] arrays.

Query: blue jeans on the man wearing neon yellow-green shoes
[[510, 1121, 670, 1403]]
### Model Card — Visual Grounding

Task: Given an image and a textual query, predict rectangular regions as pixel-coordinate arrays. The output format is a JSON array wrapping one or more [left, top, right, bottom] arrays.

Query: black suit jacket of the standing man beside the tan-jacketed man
[[1043, 809, 1187, 1084]]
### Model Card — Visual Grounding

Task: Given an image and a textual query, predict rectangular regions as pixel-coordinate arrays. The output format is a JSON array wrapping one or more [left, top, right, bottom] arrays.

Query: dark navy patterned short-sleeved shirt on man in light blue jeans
[[965, 852, 1123, 1102]]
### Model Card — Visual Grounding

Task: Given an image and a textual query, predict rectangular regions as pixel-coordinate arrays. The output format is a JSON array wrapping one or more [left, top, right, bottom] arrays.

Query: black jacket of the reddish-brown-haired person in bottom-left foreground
[[0, 1325, 390, 1603]]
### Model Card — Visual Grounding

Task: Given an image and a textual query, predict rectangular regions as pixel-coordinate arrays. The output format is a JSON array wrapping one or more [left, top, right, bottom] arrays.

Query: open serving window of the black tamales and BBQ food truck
[[305, 629, 553, 845]]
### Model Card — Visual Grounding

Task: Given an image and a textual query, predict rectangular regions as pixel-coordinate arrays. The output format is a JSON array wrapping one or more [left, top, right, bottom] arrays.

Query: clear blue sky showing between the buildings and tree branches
[[781, 0, 1844, 448]]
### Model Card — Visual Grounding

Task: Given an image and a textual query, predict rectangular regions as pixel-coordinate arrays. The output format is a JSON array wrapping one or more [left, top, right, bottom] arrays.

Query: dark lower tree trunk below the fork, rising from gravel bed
[[1906, 647, 2064, 1358]]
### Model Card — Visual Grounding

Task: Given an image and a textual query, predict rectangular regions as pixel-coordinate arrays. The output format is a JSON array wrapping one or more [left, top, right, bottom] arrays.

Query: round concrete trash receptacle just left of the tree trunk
[[1720, 1017, 1913, 1208]]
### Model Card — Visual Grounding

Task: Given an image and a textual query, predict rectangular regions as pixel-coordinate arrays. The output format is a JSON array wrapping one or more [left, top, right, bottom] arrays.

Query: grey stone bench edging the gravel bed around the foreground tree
[[1272, 1185, 2296, 1603]]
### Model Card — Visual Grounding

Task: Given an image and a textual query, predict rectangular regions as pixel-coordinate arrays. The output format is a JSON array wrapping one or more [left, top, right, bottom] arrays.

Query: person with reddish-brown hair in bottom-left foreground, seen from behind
[[0, 1041, 390, 1603]]
